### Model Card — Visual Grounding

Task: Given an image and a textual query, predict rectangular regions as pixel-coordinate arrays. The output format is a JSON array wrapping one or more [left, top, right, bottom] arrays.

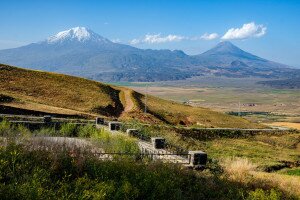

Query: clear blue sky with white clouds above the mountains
[[0, 0, 300, 67]]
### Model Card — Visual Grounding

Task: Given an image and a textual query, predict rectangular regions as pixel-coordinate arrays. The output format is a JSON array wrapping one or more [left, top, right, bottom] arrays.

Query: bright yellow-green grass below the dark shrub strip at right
[[195, 134, 300, 168]]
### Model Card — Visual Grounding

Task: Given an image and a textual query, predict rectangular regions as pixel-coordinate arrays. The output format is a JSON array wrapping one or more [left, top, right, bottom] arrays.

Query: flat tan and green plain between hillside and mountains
[[115, 76, 300, 126]]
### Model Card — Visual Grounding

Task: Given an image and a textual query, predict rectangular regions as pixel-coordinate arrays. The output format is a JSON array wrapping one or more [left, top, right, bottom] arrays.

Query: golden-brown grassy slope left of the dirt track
[[0, 65, 118, 116]]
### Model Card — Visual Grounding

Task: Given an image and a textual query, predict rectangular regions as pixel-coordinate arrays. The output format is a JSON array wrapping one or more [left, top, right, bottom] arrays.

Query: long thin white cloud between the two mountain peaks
[[130, 34, 187, 44]]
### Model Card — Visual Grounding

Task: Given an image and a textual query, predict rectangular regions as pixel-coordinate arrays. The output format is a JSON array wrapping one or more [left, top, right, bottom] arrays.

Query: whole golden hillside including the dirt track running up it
[[0, 65, 261, 128]]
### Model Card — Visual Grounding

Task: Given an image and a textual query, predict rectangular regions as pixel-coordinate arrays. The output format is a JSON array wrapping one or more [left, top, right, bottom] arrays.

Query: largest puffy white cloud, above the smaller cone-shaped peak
[[222, 22, 267, 40]]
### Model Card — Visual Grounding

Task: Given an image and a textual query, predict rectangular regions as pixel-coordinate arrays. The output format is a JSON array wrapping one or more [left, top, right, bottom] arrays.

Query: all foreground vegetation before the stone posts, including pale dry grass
[[0, 120, 299, 199]]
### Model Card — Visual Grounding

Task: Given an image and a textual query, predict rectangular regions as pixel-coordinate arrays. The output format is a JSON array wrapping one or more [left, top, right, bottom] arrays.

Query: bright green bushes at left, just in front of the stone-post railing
[[0, 120, 139, 154]]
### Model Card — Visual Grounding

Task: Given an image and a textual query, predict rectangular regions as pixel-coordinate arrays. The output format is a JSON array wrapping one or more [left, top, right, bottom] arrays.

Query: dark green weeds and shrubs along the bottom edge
[[0, 143, 293, 199]]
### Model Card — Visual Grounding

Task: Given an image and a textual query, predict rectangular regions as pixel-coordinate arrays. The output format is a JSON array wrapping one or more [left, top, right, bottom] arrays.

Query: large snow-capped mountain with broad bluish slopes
[[0, 27, 196, 81]]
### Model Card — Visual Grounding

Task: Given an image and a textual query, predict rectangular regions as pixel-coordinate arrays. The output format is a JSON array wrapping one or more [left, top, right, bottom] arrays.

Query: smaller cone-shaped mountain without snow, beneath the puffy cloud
[[194, 41, 300, 78]]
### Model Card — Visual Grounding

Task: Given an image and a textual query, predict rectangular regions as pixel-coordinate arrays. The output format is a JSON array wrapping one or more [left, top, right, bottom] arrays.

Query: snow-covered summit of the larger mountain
[[47, 27, 109, 44]]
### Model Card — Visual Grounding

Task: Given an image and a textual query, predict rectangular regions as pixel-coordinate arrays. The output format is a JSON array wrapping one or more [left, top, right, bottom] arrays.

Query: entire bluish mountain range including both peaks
[[0, 27, 300, 82]]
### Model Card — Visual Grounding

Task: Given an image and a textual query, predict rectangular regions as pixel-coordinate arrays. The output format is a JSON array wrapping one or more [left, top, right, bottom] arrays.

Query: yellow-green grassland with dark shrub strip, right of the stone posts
[[125, 121, 300, 168]]
